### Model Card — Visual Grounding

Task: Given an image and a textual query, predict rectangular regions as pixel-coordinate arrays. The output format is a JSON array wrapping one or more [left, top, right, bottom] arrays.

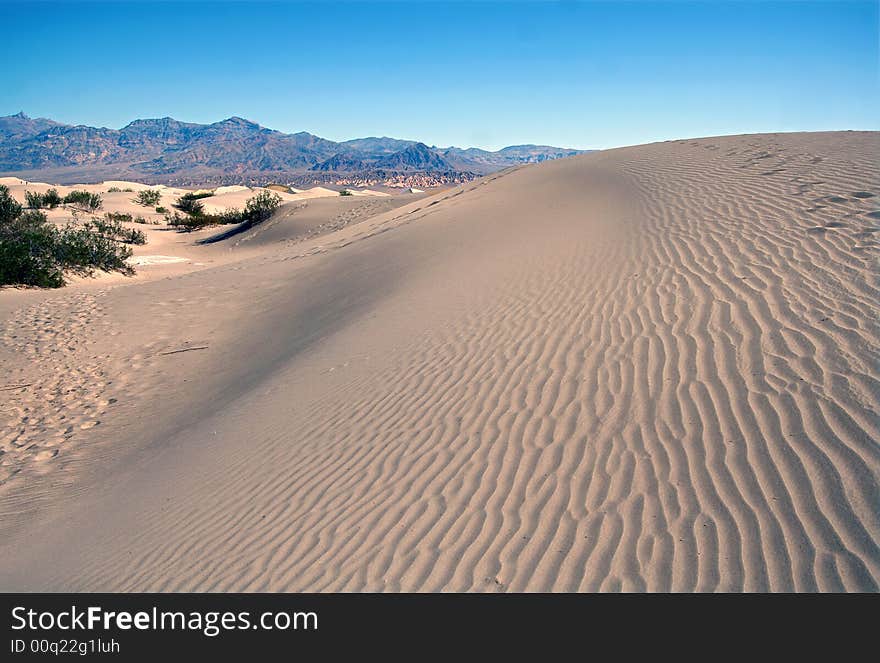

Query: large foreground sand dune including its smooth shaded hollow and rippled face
[[0, 132, 880, 591]]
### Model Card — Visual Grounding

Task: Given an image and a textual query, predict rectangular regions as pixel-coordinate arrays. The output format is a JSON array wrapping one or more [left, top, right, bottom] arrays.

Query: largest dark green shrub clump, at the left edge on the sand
[[0, 185, 133, 288]]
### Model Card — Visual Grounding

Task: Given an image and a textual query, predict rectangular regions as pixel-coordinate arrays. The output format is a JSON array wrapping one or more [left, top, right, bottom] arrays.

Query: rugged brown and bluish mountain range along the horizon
[[0, 113, 581, 185]]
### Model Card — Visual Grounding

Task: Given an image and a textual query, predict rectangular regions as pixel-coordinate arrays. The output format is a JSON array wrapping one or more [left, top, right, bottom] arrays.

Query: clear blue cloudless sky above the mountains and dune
[[0, 0, 880, 149]]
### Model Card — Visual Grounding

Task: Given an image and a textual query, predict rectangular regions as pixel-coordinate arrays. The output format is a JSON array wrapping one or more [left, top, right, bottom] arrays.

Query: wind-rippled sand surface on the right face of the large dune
[[6, 134, 880, 592]]
